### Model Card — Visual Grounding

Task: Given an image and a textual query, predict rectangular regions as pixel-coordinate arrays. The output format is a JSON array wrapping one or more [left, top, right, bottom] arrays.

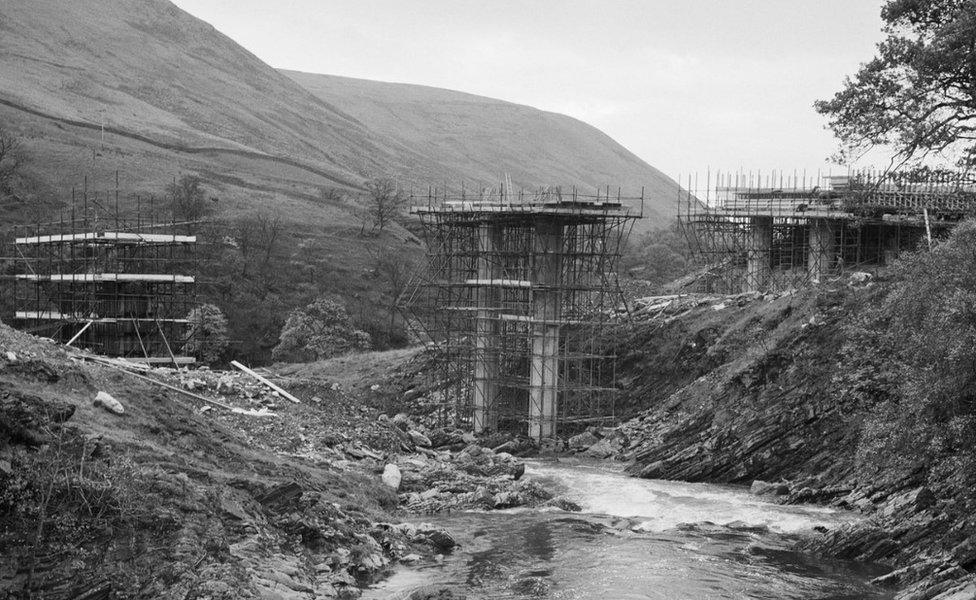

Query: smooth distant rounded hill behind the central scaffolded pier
[[282, 70, 676, 224]]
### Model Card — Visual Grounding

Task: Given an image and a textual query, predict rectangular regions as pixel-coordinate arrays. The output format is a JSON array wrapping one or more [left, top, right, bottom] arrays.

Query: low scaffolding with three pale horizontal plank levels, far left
[[10, 183, 197, 366]]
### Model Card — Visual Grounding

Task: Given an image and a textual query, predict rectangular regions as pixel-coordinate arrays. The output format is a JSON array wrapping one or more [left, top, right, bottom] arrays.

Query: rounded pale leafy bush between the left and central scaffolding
[[271, 297, 372, 362]]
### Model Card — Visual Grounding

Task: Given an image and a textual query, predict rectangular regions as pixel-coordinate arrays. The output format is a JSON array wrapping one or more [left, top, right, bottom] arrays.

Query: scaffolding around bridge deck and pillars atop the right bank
[[678, 171, 976, 293]]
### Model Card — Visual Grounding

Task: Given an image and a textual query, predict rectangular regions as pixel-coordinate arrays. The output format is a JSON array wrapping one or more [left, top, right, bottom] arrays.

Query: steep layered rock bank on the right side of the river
[[601, 281, 976, 599]]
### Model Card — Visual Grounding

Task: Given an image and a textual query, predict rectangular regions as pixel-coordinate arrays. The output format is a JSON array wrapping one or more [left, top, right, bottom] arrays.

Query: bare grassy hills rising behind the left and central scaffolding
[[0, 0, 676, 360]]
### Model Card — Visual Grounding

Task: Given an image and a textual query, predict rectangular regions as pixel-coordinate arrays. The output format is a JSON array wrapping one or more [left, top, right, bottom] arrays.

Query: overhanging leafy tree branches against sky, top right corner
[[814, 0, 976, 167]]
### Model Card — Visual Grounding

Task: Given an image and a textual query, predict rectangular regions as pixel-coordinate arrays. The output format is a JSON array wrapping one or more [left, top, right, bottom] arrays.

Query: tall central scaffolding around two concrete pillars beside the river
[[406, 185, 640, 439]]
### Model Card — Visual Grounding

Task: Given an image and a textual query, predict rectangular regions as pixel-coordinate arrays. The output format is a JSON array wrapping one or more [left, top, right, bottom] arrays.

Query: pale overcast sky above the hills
[[175, 0, 882, 176]]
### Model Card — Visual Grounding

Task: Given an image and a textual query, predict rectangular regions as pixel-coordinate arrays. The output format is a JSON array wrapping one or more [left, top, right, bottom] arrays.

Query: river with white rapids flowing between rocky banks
[[364, 461, 887, 600]]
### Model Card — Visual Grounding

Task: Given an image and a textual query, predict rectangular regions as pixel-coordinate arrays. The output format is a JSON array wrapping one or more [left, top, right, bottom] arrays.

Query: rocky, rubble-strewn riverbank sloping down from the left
[[0, 324, 553, 600]]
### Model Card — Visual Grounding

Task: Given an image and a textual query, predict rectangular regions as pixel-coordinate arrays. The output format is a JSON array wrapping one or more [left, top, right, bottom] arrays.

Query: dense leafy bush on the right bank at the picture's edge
[[860, 221, 976, 483]]
